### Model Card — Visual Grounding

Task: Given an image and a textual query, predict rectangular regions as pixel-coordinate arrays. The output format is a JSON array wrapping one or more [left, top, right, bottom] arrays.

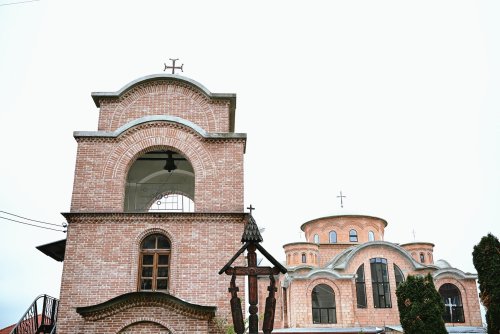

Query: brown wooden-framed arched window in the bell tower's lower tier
[[139, 234, 170, 292]]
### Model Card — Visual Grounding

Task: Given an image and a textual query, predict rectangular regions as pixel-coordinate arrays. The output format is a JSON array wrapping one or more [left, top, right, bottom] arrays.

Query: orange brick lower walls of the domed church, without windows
[[274, 244, 481, 328]]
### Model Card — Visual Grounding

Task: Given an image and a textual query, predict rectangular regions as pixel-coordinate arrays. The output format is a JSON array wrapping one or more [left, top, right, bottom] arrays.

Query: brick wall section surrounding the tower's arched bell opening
[[71, 122, 245, 212]]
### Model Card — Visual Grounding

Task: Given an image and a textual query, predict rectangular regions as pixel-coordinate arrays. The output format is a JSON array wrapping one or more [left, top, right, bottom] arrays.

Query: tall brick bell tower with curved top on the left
[[57, 74, 248, 333]]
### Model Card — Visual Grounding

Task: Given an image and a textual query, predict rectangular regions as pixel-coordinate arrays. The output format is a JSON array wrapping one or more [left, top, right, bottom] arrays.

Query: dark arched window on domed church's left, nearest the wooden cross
[[311, 284, 337, 324]]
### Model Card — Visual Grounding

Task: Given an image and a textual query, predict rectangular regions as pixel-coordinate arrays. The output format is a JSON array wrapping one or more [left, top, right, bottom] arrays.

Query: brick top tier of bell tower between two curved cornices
[[98, 79, 229, 132]]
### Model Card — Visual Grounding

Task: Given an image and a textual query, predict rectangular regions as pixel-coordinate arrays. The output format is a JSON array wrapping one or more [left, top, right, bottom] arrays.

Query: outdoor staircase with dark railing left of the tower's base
[[10, 295, 59, 334]]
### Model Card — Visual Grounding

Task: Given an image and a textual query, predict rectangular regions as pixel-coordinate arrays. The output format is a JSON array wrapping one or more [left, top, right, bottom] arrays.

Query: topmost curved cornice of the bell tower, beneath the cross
[[90, 74, 236, 132]]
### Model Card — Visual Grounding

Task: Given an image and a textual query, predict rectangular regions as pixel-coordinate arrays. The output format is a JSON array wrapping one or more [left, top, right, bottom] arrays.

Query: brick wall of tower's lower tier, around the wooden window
[[58, 213, 244, 334]]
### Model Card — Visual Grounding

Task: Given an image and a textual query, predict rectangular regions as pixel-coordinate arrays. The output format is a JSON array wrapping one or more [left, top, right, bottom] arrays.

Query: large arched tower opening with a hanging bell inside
[[124, 149, 195, 212]]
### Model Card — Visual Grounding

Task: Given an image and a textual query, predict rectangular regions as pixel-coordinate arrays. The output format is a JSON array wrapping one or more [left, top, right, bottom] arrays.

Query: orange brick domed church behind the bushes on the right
[[261, 215, 482, 333]]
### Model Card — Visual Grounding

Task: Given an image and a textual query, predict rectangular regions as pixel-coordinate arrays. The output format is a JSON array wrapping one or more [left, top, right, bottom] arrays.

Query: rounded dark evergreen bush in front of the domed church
[[396, 274, 448, 334]]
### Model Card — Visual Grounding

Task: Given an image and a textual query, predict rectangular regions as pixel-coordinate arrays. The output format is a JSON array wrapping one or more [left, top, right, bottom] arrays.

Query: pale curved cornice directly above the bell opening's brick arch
[[73, 115, 247, 139]]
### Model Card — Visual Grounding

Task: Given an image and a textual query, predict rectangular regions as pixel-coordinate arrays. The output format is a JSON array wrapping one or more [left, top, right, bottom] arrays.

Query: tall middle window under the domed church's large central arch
[[370, 257, 392, 308]]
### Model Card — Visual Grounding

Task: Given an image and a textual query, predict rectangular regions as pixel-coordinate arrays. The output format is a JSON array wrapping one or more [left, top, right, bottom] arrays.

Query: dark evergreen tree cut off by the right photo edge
[[472, 233, 500, 334]]
